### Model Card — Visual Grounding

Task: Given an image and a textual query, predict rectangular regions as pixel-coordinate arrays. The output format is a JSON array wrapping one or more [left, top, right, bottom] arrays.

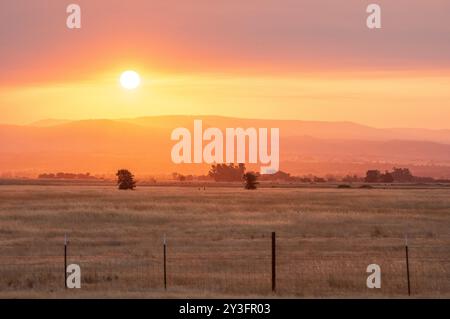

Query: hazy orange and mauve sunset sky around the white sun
[[0, 0, 450, 128]]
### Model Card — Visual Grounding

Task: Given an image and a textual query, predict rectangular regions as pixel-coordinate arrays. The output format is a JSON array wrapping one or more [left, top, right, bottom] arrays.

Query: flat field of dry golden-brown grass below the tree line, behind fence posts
[[0, 185, 450, 298]]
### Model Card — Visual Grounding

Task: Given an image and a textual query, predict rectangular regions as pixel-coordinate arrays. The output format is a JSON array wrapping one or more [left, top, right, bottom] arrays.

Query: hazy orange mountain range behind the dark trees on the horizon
[[0, 115, 450, 178]]
